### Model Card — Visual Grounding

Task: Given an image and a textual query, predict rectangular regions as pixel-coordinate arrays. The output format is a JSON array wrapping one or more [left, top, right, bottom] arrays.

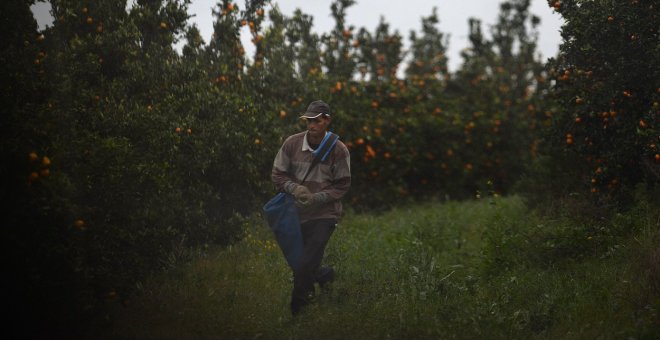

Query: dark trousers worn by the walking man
[[291, 219, 337, 309]]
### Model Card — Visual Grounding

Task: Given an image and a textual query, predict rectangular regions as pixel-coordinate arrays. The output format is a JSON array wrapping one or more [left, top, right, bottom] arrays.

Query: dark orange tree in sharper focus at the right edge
[[546, 0, 660, 205]]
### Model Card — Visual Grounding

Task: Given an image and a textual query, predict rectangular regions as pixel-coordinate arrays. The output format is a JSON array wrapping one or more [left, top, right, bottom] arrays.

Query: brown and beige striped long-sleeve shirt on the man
[[271, 131, 351, 223]]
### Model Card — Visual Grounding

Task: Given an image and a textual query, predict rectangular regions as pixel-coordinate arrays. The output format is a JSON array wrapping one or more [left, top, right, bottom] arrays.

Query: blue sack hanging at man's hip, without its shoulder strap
[[263, 192, 303, 270]]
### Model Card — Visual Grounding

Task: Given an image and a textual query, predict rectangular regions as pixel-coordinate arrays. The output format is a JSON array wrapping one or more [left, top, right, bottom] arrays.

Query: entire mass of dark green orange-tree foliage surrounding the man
[[0, 0, 660, 333]]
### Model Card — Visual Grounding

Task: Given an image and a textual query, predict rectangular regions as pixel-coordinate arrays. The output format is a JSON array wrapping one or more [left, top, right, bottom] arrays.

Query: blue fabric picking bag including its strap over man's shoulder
[[263, 132, 339, 271]]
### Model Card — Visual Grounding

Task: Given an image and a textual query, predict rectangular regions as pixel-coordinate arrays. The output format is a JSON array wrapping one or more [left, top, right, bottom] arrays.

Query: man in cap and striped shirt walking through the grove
[[272, 100, 351, 315]]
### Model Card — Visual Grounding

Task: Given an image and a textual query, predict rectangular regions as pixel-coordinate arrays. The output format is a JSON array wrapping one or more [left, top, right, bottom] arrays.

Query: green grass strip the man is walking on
[[99, 197, 660, 339]]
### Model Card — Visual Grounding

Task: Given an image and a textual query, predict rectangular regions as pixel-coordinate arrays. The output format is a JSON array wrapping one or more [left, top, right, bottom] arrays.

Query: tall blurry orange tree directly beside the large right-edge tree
[[448, 1, 547, 198]]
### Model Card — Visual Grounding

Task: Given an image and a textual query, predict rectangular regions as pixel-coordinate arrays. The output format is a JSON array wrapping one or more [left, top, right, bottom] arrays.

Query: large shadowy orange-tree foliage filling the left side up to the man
[[1, 0, 273, 336]]
